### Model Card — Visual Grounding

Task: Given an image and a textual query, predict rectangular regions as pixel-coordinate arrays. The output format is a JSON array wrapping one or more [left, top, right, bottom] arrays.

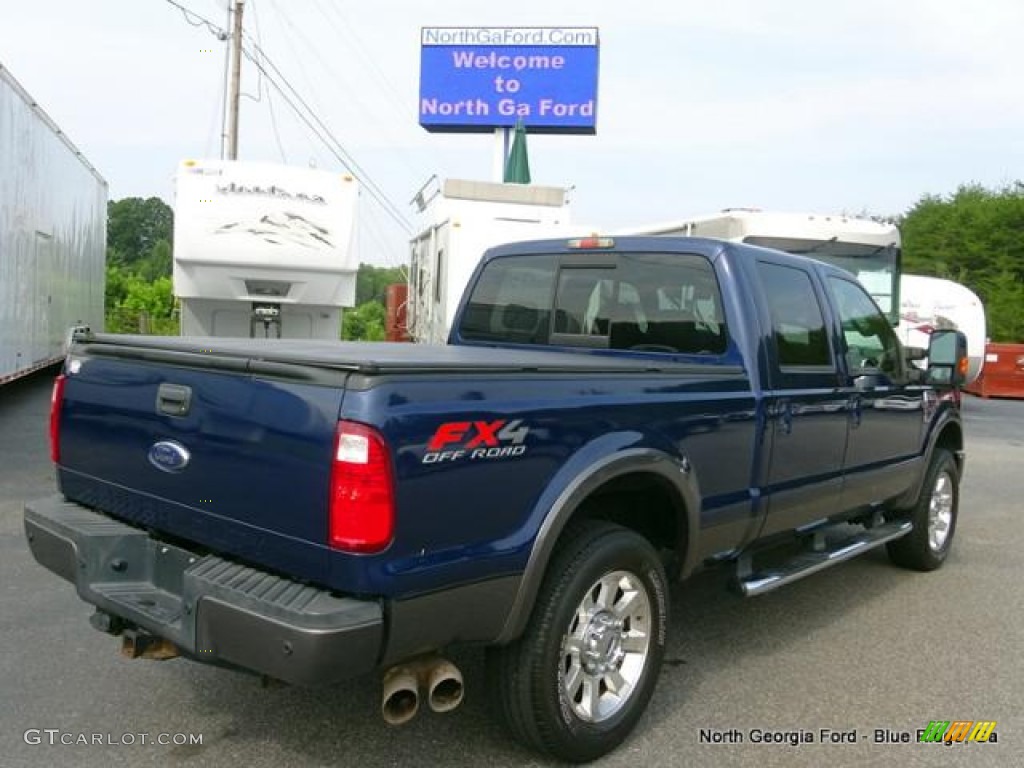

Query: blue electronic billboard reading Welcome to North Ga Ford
[[420, 27, 598, 133]]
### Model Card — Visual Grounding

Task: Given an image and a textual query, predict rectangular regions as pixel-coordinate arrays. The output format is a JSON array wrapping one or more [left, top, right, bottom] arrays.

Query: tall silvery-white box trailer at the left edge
[[0, 65, 106, 384]]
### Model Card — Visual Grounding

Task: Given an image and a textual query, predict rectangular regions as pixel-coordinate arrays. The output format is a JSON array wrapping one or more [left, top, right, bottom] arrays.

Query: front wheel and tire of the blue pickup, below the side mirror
[[887, 449, 959, 570]]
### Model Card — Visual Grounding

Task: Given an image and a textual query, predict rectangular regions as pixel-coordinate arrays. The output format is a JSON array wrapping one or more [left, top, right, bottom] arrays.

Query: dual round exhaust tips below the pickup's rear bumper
[[381, 656, 463, 725]]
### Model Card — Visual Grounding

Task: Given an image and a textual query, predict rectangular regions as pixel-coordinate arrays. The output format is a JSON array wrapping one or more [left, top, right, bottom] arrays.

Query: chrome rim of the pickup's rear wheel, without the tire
[[558, 570, 651, 723]]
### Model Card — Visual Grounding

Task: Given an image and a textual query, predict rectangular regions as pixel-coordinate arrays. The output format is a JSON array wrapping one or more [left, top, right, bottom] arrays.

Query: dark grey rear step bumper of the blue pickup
[[25, 496, 384, 685]]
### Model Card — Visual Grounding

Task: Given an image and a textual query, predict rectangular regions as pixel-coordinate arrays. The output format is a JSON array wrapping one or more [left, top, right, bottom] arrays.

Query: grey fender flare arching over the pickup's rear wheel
[[495, 447, 700, 645]]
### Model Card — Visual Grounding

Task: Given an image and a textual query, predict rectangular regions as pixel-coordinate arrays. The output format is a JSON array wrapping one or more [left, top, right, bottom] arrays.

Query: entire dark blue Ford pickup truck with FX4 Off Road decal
[[25, 238, 964, 762]]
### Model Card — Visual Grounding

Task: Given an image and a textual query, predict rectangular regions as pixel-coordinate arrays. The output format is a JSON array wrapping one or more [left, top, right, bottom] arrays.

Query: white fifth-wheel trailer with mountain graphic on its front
[[174, 160, 358, 339]]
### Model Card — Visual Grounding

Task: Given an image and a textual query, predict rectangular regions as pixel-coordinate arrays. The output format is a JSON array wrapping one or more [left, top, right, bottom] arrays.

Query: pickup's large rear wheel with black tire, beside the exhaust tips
[[487, 521, 668, 763]]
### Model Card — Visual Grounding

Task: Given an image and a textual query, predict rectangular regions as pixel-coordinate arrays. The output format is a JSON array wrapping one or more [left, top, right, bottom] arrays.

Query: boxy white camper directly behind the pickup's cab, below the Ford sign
[[407, 178, 585, 344]]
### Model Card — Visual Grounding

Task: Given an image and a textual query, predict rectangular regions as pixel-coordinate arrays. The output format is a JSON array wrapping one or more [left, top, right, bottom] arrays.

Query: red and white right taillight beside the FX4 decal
[[328, 421, 394, 552]]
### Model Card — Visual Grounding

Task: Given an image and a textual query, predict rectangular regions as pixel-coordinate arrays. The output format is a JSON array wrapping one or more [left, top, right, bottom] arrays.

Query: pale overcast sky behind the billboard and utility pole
[[0, 0, 1024, 264]]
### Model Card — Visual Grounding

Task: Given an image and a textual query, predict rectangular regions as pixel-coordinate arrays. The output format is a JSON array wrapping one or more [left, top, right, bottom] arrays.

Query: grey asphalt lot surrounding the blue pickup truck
[[0, 373, 1024, 768]]
